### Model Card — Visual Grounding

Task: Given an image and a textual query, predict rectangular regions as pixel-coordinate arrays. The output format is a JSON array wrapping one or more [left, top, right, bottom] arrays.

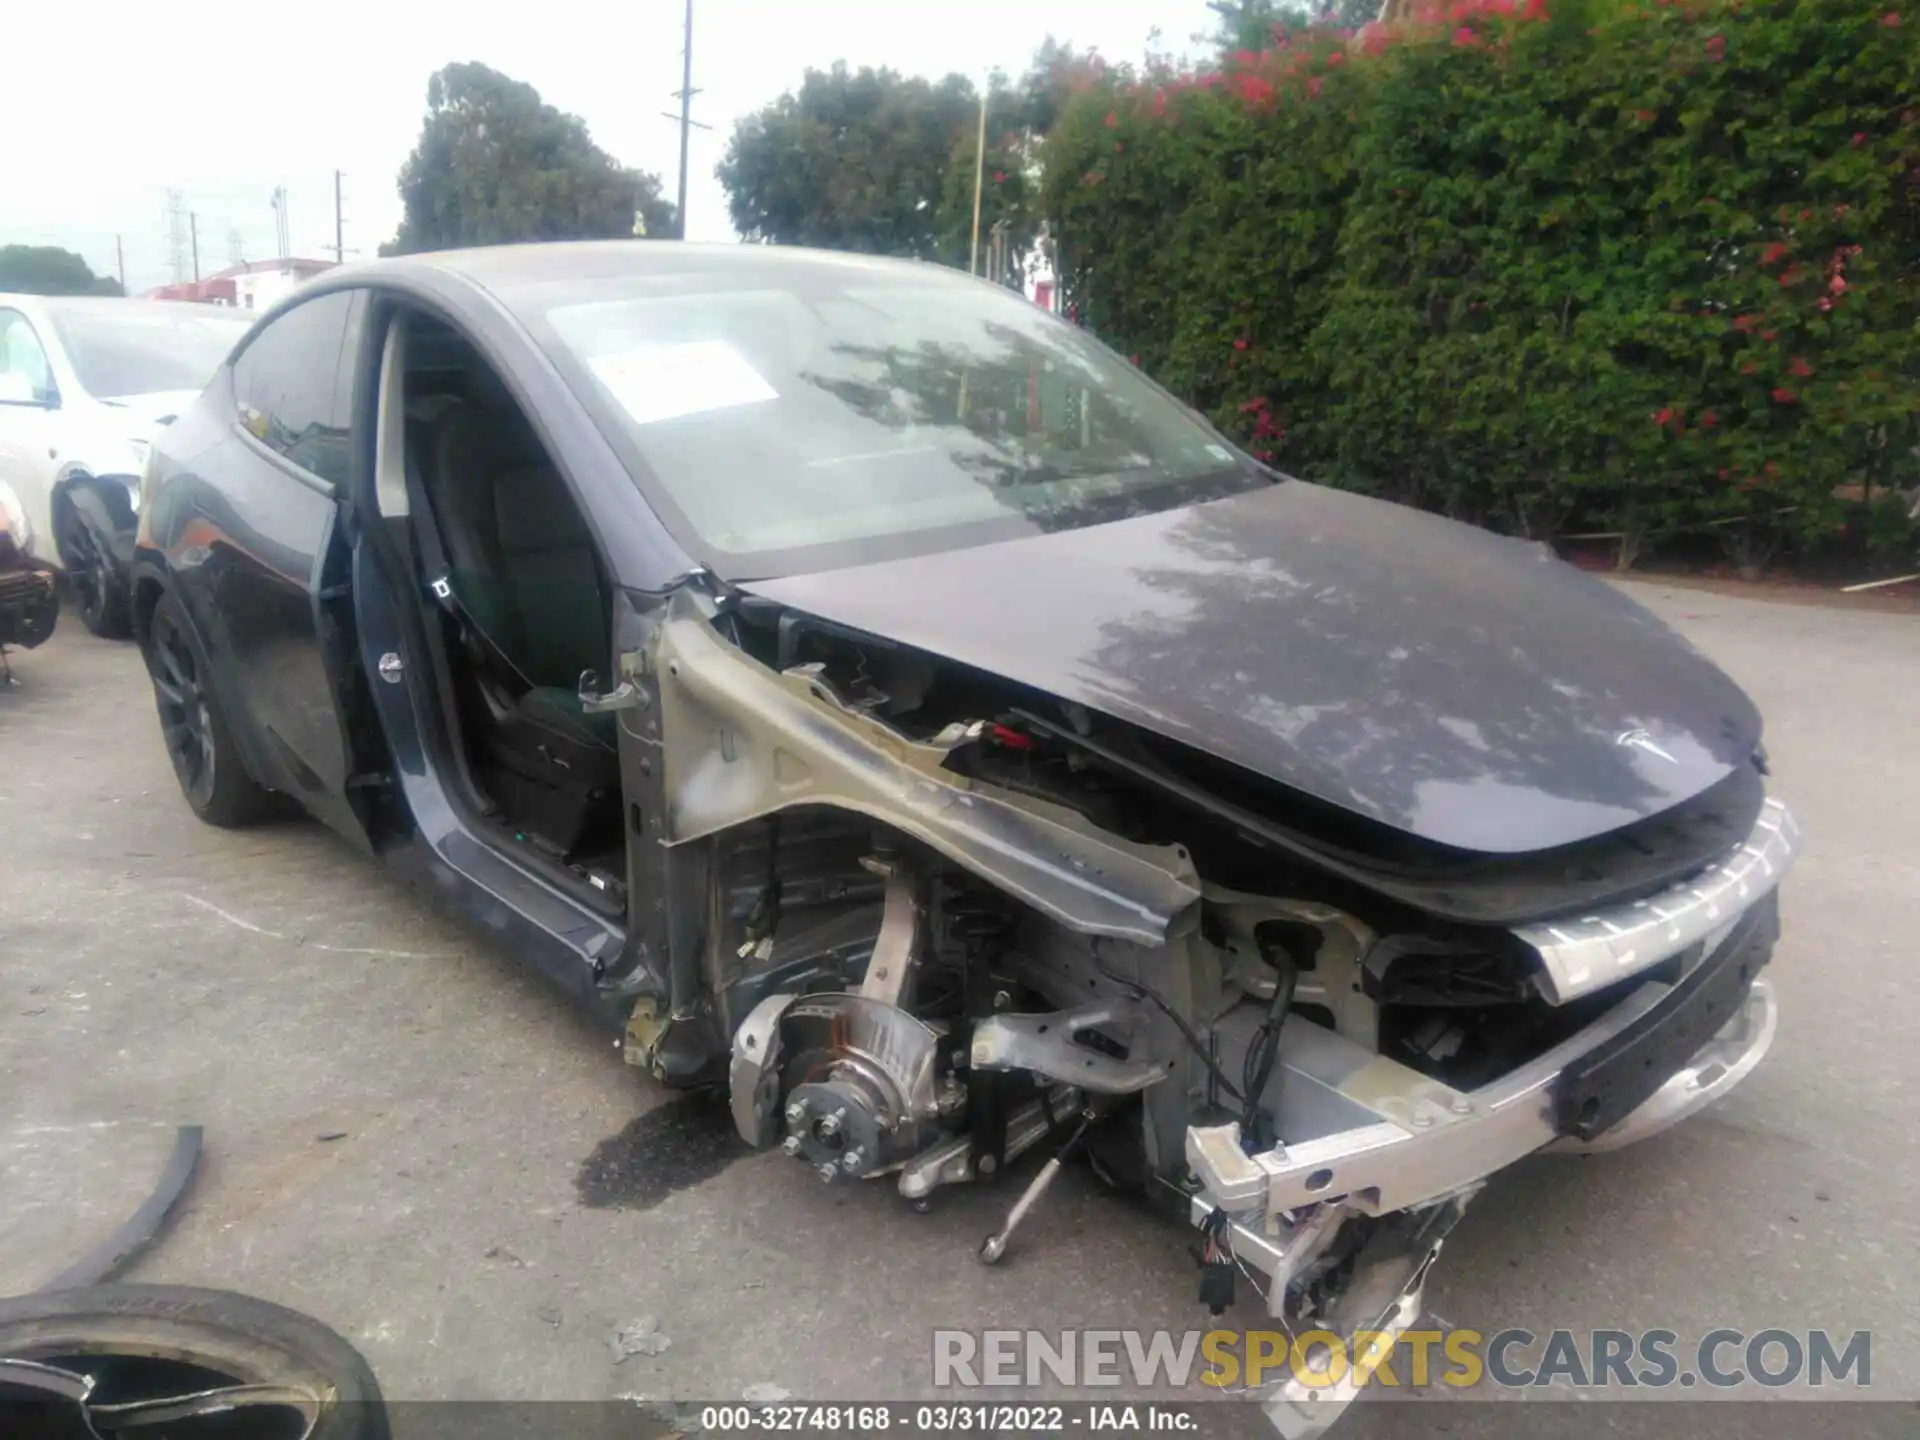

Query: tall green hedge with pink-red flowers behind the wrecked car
[[1043, 0, 1920, 564]]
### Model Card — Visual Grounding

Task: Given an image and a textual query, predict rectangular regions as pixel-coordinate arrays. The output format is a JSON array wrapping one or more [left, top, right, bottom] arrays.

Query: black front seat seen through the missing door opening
[[419, 399, 618, 852]]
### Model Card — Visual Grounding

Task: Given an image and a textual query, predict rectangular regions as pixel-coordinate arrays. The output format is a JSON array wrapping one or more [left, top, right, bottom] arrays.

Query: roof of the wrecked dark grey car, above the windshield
[[326, 238, 977, 307]]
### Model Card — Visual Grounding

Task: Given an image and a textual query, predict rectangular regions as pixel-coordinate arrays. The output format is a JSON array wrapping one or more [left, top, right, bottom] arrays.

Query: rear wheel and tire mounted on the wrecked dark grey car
[[144, 595, 275, 829]]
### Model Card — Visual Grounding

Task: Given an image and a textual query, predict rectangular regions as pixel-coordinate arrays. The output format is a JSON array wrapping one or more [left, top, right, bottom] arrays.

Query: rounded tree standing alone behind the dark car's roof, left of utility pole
[[380, 63, 680, 255]]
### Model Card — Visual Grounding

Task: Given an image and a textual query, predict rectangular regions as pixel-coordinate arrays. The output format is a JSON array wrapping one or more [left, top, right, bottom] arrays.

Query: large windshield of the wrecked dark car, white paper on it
[[545, 267, 1260, 572]]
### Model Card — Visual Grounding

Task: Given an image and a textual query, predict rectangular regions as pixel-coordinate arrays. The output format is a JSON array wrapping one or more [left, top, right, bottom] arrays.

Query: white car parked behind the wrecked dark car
[[0, 296, 252, 637]]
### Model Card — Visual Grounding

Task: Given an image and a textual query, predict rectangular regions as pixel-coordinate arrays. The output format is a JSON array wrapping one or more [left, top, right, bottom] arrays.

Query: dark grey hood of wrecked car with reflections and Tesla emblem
[[745, 480, 1761, 854]]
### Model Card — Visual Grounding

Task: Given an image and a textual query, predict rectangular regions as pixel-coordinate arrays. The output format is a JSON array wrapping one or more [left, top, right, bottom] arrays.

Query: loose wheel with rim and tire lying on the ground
[[0, 1284, 388, 1440]]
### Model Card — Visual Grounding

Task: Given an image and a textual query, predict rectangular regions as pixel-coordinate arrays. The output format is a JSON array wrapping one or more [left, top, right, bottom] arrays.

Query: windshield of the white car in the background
[[52, 301, 248, 399]]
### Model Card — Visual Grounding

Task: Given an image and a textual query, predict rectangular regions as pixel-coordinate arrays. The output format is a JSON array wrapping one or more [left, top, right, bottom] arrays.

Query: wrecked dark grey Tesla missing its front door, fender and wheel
[[132, 244, 1797, 1417]]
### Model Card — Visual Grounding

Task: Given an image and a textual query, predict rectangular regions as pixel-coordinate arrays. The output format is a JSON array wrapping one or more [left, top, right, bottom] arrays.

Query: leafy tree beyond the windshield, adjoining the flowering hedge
[[718, 65, 1037, 278]]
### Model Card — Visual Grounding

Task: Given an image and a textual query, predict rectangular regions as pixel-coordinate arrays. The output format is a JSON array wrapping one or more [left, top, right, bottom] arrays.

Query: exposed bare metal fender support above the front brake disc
[[655, 589, 1200, 945]]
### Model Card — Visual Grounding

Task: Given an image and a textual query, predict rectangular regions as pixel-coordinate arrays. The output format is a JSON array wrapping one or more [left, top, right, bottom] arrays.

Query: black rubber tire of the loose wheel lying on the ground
[[0, 1284, 390, 1440]]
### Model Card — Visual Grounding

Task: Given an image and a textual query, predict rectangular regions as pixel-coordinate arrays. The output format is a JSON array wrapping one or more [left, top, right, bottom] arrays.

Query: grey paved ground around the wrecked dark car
[[0, 586, 1920, 1434]]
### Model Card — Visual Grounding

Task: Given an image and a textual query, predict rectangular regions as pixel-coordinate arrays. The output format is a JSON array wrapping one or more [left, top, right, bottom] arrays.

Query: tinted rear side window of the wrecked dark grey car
[[234, 290, 353, 484]]
